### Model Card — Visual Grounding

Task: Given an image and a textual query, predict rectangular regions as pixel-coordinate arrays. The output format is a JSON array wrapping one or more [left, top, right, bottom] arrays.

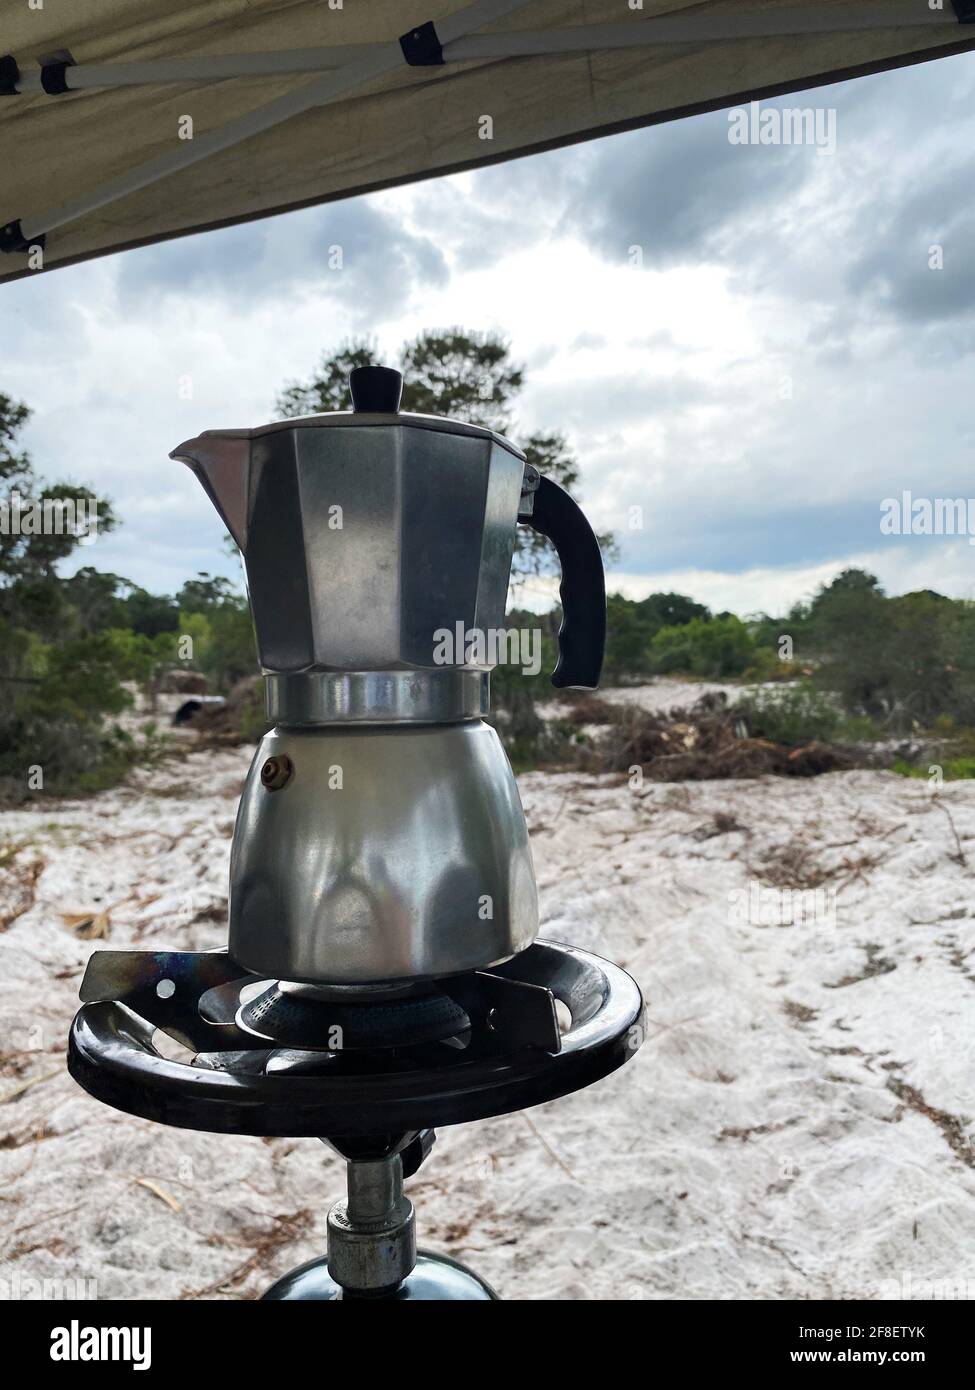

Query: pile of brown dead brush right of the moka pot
[[565, 694, 855, 781]]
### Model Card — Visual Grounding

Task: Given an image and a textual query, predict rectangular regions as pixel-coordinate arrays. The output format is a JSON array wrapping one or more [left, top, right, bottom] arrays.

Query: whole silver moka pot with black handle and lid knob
[[172, 367, 605, 987]]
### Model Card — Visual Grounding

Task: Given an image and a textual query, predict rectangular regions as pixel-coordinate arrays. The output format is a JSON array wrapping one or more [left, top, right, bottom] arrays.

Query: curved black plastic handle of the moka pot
[[520, 474, 606, 691]]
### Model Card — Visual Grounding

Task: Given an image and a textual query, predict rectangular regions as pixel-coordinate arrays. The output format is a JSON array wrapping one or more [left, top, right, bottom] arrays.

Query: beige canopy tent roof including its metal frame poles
[[0, 0, 975, 279]]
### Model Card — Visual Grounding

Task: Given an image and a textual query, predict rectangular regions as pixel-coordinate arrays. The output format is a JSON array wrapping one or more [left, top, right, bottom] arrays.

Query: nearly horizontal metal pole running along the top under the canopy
[[1, 0, 962, 95]]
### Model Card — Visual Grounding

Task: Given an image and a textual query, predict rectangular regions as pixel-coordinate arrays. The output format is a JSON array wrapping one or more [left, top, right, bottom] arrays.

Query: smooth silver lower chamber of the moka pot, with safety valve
[[229, 719, 538, 988]]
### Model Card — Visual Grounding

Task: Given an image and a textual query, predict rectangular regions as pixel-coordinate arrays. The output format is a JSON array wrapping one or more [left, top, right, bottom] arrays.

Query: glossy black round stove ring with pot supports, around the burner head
[[68, 941, 644, 1138]]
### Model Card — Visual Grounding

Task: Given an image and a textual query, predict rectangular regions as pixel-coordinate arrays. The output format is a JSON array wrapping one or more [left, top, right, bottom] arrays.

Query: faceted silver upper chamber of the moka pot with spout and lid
[[172, 367, 524, 686]]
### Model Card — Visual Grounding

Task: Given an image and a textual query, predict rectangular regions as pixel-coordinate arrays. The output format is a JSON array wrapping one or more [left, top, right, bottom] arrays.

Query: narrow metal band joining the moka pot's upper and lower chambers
[[264, 666, 491, 727]]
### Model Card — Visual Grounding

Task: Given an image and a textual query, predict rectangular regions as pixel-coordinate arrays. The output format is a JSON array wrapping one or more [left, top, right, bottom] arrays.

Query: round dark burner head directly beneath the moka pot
[[235, 980, 470, 1052]]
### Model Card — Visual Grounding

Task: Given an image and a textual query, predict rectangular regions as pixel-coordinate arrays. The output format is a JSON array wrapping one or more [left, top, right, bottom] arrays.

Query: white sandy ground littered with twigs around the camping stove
[[0, 701, 975, 1300]]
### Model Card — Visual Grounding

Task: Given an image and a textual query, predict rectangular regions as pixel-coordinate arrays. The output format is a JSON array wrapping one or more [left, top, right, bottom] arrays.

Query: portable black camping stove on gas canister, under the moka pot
[[68, 941, 643, 1300]]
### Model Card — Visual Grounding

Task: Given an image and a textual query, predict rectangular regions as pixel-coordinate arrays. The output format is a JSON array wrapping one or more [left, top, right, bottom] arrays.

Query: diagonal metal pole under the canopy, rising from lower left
[[3, 0, 529, 250]]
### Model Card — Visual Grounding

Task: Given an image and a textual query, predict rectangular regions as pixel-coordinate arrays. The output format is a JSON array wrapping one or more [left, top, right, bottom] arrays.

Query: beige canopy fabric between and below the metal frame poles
[[0, 0, 975, 279]]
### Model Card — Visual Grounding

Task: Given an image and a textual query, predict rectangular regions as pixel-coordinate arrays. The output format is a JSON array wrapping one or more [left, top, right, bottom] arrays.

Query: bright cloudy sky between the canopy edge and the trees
[[0, 46, 975, 613]]
